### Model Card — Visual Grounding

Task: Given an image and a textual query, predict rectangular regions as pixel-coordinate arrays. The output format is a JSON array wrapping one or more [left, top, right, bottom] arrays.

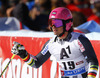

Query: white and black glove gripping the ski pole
[[11, 41, 28, 58]]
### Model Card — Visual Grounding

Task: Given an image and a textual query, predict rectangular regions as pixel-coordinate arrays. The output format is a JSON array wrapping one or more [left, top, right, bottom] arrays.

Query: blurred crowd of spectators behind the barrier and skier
[[0, 0, 100, 31]]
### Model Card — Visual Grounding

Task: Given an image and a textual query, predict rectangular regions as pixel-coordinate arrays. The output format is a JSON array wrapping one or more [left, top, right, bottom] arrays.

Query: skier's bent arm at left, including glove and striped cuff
[[12, 42, 51, 68]]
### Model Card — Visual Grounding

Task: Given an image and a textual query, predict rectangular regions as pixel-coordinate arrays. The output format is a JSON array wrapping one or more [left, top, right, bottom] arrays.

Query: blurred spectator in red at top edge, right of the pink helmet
[[66, 0, 92, 17]]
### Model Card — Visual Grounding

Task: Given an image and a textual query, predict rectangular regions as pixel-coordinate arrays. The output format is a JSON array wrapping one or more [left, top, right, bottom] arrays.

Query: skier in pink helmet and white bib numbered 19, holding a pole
[[11, 7, 98, 78]]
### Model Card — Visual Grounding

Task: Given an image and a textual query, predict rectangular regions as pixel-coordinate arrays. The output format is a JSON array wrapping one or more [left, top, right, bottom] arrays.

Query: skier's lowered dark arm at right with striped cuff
[[79, 35, 98, 78]]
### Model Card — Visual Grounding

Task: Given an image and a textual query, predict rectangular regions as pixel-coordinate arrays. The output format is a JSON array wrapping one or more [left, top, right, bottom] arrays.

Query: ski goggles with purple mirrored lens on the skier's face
[[49, 19, 63, 28]]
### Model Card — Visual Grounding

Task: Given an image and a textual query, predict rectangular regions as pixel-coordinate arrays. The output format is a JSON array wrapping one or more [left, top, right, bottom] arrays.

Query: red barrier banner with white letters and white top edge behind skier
[[0, 30, 100, 78]]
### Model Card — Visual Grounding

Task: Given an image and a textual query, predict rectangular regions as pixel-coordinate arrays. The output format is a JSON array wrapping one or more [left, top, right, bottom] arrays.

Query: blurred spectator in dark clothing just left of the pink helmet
[[30, 0, 51, 31]]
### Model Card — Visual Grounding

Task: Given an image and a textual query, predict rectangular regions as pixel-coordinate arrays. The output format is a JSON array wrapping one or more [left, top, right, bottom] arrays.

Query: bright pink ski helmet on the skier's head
[[49, 7, 73, 31]]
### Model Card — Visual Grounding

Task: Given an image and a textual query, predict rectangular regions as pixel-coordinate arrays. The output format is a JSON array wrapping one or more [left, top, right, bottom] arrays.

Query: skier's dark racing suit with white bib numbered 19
[[22, 32, 98, 78]]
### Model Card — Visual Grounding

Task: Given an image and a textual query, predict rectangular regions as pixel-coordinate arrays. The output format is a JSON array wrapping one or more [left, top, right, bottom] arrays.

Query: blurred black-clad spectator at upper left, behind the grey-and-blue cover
[[12, 3, 39, 31]]
